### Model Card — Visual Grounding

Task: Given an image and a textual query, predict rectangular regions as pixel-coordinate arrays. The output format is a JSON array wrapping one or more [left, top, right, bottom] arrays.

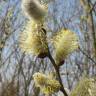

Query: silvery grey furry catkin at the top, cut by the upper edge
[[21, 0, 46, 21]]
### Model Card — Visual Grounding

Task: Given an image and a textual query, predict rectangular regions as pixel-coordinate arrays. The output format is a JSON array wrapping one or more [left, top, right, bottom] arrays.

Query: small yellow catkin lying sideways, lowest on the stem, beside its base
[[33, 73, 60, 94]]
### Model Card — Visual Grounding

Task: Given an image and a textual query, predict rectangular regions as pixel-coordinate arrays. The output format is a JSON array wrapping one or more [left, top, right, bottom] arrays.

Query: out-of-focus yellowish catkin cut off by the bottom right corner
[[70, 78, 96, 96]]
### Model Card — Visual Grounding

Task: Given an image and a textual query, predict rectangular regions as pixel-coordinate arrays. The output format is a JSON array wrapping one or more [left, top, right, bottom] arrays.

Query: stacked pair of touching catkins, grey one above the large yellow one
[[19, 0, 48, 58]]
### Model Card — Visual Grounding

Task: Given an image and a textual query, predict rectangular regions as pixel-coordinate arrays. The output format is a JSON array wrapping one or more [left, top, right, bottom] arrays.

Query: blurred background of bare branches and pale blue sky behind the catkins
[[0, 0, 96, 96]]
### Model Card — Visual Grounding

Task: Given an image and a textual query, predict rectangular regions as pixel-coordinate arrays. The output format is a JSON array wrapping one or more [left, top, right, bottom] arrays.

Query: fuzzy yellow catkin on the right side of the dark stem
[[52, 29, 78, 64]]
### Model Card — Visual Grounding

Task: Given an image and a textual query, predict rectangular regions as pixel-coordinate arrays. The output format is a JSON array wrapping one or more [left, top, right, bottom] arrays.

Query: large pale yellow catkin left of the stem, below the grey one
[[19, 21, 48, 57]]
